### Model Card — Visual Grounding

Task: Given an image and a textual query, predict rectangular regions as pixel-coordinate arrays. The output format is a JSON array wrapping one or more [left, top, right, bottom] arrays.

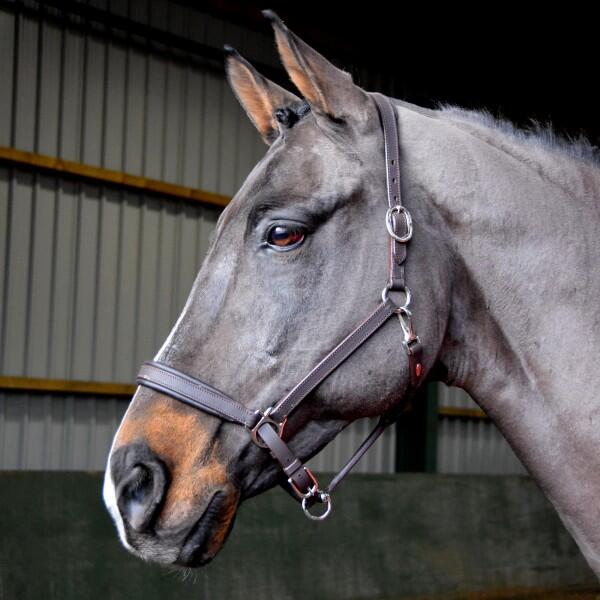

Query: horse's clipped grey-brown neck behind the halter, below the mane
[[401, 105, 600, 572]]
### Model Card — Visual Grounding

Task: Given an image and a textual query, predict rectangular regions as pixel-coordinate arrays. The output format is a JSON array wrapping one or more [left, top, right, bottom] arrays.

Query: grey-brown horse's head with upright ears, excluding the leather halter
[[104, 11, 449, 566]]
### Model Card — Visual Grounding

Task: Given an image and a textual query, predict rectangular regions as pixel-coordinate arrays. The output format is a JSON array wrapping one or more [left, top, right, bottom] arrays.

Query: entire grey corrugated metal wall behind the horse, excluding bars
[[0, 0, 514, 472]]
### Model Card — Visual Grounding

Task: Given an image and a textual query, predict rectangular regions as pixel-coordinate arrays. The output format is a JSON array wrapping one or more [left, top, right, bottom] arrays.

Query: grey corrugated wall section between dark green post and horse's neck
[[437, 384, 525, 475]]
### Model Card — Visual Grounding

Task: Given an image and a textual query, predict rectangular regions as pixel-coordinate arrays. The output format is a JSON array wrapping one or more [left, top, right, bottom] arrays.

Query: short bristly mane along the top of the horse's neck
[[437, 103, 600, 167]]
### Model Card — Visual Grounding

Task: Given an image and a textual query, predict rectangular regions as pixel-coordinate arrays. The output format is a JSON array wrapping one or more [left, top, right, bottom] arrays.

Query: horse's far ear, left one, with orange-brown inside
[[225, 46, 301, 145]]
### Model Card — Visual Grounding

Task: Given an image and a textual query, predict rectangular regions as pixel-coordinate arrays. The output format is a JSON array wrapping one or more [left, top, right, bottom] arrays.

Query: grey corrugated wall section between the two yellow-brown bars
[[0, 167, 219, 382]]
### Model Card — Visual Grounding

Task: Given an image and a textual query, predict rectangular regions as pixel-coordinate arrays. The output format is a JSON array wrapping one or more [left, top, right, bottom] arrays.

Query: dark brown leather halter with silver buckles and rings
[[137, 93, 423, 520]]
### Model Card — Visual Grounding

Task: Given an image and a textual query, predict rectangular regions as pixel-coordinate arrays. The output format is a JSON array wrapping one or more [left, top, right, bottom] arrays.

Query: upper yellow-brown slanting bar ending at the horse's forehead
[[0, 146, 231, 207]]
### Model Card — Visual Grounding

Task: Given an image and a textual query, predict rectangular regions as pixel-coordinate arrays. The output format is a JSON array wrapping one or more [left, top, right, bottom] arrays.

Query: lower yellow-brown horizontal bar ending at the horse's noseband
[[0, 376, 136, 397]]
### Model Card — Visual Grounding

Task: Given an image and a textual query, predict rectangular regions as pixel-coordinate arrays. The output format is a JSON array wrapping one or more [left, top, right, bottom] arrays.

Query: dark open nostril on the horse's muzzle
[[113, 446, 167, 531]]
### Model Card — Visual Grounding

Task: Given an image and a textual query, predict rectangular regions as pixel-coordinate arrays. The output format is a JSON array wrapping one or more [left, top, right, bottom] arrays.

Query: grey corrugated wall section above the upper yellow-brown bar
[[0, 2, 272, 195]]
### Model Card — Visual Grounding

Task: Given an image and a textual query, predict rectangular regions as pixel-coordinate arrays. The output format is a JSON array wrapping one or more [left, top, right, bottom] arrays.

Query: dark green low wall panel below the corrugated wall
[[0, 472, 596, 600]]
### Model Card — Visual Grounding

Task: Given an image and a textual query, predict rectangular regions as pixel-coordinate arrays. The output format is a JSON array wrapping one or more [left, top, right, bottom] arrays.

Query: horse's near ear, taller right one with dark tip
[[262, 10, 369, 122]]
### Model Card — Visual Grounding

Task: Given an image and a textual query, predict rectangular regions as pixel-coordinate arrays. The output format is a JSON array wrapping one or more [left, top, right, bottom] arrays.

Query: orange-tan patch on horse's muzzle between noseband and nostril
[[113, 390, 238, 532]]
